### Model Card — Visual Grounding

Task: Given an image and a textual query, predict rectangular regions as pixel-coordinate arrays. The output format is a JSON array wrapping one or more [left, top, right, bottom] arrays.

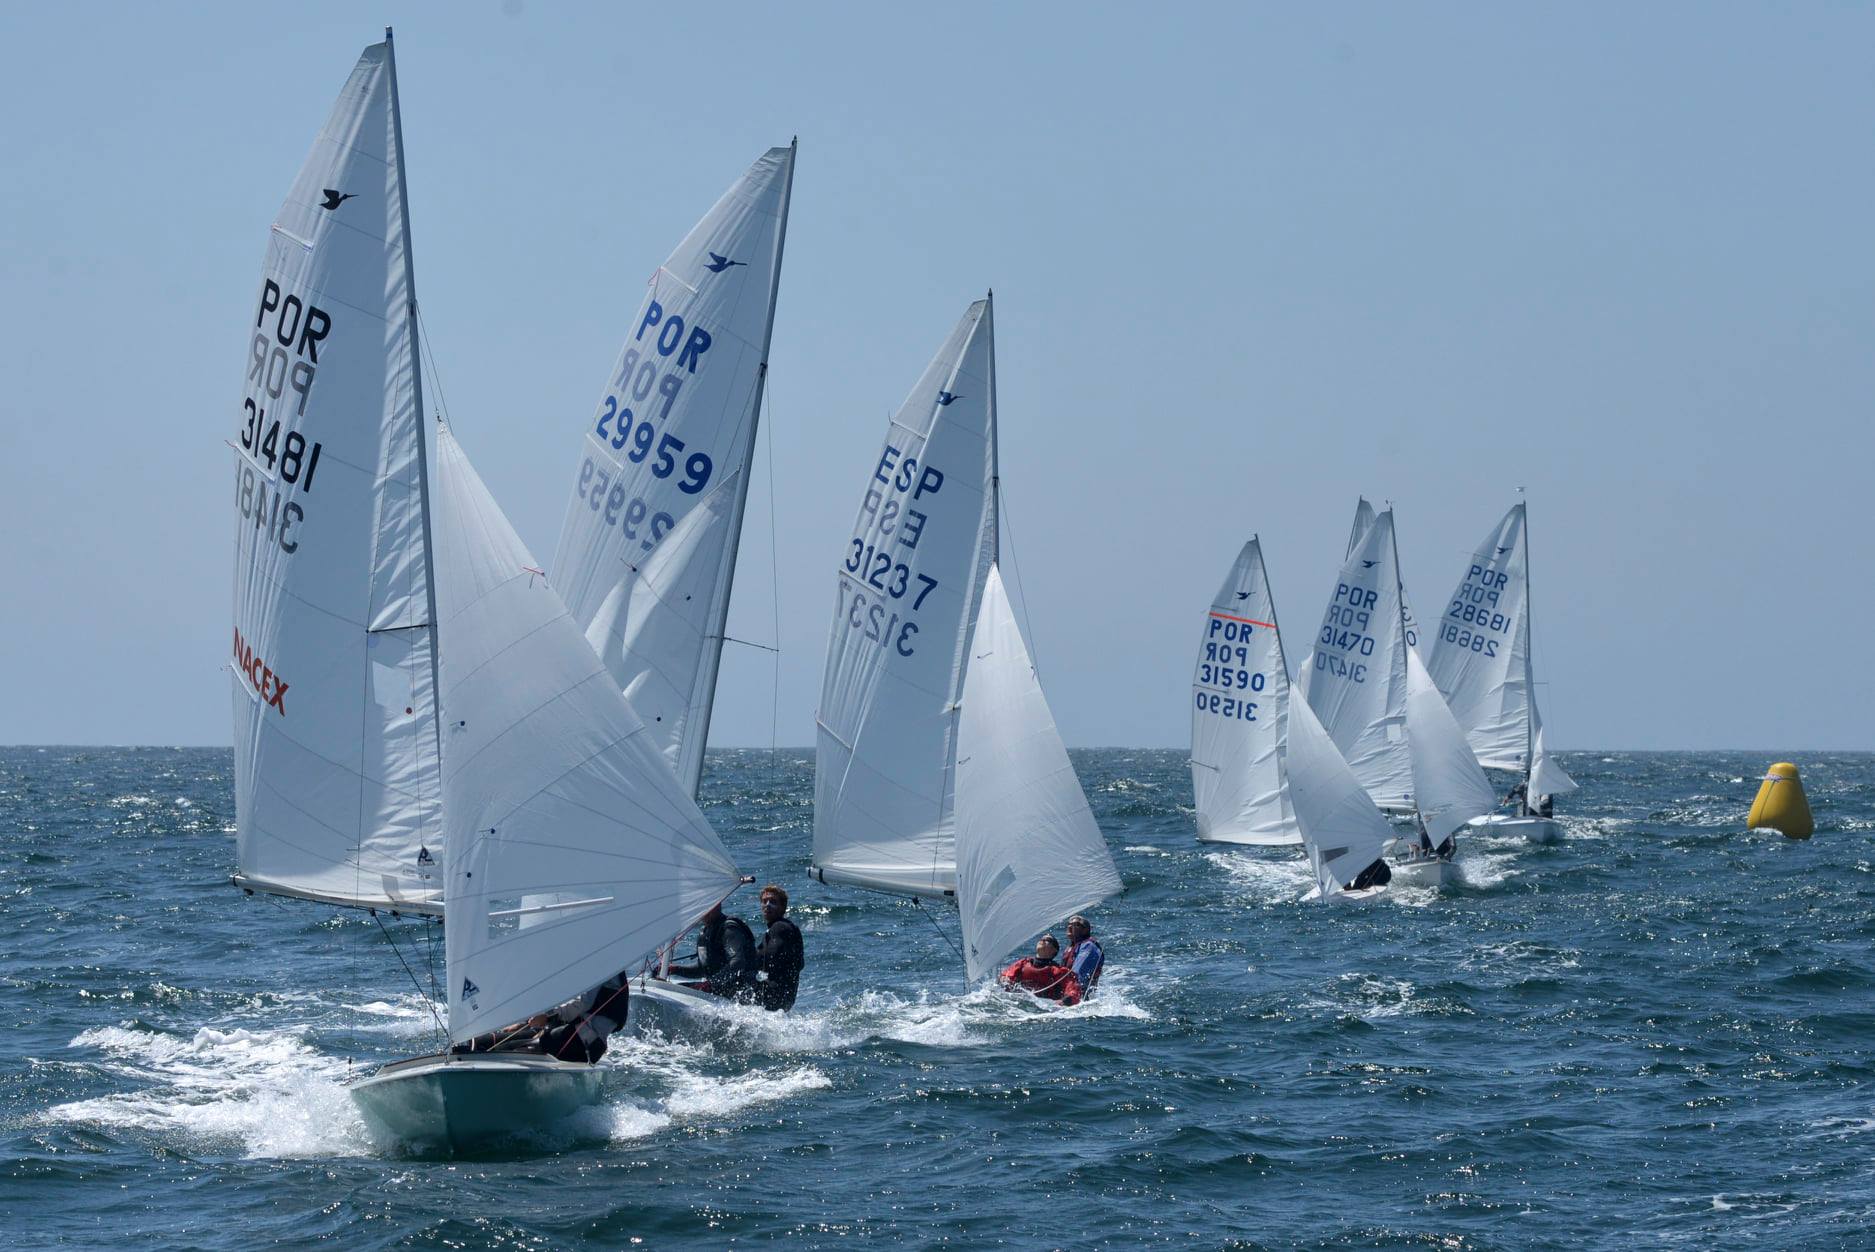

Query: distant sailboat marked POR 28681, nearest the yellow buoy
[[1427, 500, 1575, 843]]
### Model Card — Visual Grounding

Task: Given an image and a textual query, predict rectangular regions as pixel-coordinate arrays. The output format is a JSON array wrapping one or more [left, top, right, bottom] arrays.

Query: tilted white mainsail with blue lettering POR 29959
[[553, 146, 795, 793]]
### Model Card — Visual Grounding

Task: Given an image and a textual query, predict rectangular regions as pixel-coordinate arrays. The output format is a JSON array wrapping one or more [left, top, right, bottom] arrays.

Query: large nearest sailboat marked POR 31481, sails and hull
[[234, 30, 739, 1147]]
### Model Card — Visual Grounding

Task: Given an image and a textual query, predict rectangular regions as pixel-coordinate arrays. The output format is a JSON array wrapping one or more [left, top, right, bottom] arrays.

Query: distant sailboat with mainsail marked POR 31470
[[1305, 508, 1496, 887]]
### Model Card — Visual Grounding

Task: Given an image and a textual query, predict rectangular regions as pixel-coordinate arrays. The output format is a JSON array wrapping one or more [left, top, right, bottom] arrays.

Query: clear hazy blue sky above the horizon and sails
[[0, 2, 1875, 750]]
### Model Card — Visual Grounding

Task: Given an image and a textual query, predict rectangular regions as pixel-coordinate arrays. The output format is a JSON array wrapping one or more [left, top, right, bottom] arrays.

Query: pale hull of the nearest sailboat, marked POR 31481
[[351, 1053, 604, 1151]]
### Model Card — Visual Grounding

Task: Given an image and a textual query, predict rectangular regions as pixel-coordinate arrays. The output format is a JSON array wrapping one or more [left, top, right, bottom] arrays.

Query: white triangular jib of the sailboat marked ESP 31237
[[956, 564, 1119, 982]]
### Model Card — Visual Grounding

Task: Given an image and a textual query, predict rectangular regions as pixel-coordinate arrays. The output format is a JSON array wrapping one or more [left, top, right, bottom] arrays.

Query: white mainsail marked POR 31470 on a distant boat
[[1301, 510, 1412, 812]]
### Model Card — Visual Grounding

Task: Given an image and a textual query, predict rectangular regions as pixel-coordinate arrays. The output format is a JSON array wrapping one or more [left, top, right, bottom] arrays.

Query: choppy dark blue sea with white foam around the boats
[[0, 748, 1875, 1250]]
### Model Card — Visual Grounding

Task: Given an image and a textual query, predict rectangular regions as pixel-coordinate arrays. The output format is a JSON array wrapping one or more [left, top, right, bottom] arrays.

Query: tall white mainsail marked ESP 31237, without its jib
[[814, 300, 996, 896]]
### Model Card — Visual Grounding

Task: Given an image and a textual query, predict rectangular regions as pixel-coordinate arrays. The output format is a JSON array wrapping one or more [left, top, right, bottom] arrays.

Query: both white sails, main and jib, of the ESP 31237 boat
[[808, 298, 1121, 982]]
